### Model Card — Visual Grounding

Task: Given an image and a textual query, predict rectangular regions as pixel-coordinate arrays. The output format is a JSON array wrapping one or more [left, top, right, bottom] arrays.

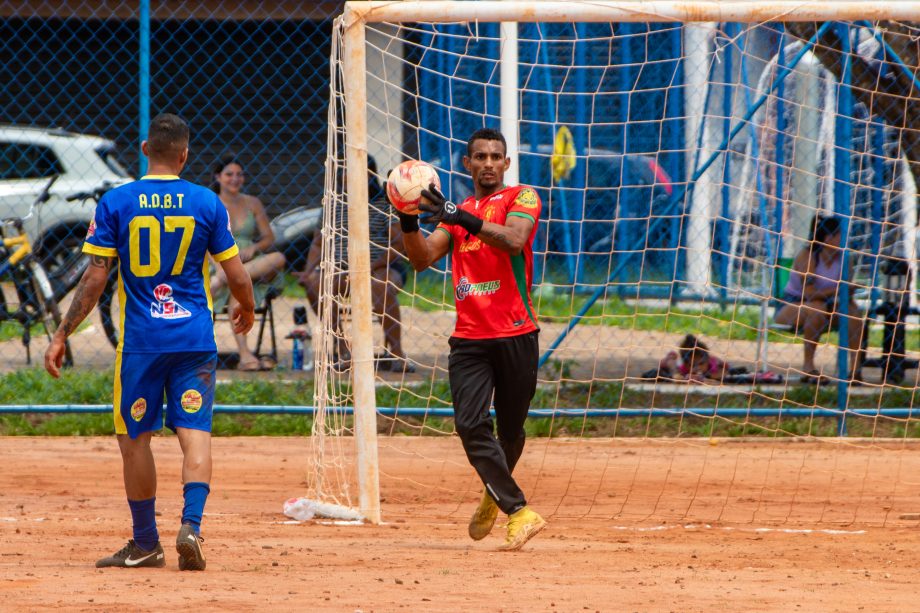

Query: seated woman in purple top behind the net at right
[[774, 214, 863, 383]]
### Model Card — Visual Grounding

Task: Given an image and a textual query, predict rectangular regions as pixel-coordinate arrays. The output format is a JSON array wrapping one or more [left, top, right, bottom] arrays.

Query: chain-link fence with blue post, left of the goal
[[0, 0, 342, 369]]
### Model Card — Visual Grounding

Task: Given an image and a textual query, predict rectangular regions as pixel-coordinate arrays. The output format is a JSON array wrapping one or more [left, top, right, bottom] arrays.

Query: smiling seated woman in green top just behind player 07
[[211, 155, 285, 371]]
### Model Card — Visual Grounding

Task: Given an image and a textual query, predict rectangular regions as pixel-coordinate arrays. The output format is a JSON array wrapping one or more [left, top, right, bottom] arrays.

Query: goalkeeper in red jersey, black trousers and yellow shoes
[[399, 129, 546, 551]]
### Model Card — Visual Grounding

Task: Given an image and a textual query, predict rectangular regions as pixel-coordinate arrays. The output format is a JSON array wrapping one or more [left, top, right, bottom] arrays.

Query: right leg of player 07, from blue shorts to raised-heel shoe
[[166, 352, 217, 570]]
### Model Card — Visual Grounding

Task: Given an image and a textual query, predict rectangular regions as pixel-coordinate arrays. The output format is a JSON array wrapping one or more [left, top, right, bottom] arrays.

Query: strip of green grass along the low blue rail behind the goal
[[7, 369, 920, 438]]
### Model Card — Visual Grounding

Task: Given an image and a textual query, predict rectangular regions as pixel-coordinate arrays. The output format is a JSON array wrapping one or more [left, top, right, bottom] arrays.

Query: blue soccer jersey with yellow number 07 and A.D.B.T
[[83, 176, 239, 353]]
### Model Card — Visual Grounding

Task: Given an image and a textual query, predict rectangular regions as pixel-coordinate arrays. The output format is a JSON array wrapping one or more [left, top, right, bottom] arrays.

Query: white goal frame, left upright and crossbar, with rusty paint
[[330, 0, 920, 523]]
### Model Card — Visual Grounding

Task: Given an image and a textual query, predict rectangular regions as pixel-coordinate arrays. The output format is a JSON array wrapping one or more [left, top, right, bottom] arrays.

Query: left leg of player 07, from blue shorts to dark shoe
[[96, 352, 166, 568]]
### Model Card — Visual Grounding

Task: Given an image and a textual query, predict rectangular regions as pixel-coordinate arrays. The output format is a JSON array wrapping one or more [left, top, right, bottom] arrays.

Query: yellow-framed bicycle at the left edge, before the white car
[[0, 175, 73, 366]]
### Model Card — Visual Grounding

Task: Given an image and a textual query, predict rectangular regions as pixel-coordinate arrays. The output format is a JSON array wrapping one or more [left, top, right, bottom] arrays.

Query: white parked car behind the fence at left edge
[[0, 125, 132, 298]]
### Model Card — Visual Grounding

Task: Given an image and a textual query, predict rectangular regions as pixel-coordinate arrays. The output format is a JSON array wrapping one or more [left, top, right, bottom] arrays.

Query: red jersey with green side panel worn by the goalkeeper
[[436, 186, 542, 339]]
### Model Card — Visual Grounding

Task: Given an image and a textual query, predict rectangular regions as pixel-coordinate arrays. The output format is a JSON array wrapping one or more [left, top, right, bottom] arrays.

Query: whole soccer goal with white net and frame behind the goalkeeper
[[296, 2, 920, 524]]
